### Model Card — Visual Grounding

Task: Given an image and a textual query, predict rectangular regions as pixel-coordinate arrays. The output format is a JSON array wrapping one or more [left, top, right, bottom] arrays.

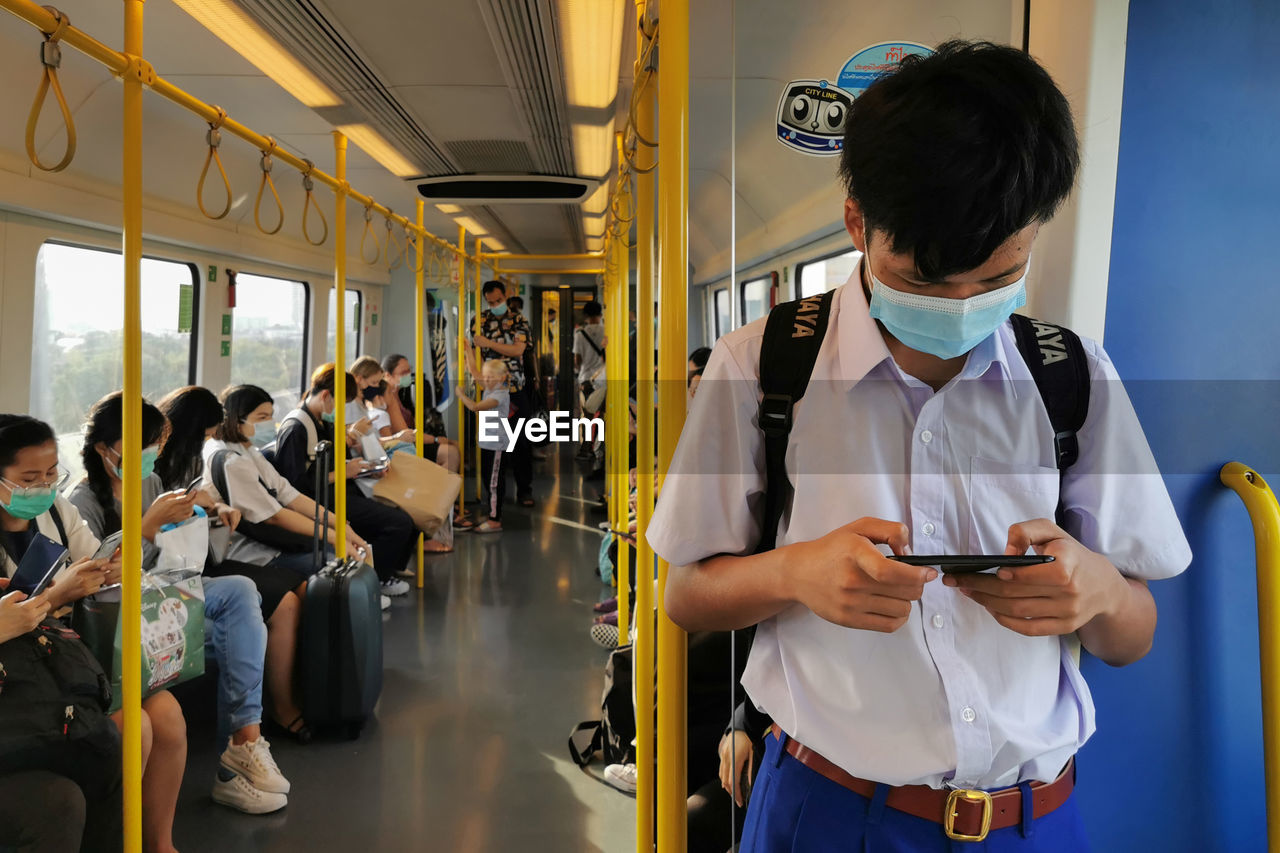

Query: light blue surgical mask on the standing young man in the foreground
[[863, 244, 1027, 359]]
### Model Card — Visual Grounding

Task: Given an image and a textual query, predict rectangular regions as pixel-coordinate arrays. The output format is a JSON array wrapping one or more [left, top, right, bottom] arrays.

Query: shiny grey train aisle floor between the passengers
[[167, 444, 635, 853]]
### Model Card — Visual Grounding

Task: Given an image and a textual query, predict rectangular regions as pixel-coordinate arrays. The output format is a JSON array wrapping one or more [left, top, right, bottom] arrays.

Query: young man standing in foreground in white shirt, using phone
[[649, 42, 1190, 853]]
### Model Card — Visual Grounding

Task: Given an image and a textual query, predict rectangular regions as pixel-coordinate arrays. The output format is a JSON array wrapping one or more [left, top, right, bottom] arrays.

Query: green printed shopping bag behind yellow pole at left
[[72, 570, 205, 712]]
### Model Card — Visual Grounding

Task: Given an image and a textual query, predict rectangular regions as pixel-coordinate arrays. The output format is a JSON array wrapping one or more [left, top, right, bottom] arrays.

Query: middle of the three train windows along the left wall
[[232, 273, 310, 419]]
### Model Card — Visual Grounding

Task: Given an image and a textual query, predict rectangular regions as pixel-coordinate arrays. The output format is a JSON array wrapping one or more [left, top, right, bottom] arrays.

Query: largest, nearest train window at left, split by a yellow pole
[[31, 242, 200, 474]]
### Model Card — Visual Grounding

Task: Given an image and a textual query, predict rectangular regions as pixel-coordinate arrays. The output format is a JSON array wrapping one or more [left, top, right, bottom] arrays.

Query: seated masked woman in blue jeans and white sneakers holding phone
[[67, 392, 289, 815]]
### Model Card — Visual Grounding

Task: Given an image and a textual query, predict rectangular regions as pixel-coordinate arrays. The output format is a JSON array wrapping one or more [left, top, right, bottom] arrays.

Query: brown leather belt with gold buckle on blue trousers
[[773, 724, 1075, 841]]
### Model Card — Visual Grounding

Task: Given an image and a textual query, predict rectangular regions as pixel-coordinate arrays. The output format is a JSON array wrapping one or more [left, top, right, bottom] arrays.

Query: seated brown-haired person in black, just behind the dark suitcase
[[274, 361, 417, 597]]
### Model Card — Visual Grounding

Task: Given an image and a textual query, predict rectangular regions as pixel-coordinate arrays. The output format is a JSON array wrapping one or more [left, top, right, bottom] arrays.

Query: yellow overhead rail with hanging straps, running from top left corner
[[0, 0, 477, 261]]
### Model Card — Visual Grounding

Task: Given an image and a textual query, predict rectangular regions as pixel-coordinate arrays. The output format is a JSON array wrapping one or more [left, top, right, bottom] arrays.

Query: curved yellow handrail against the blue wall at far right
[[1219, 462, 1280, 850]]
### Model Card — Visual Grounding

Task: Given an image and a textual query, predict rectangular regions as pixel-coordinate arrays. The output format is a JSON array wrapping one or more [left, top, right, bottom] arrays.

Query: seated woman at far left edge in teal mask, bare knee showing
[[0, 415, 187, 853]]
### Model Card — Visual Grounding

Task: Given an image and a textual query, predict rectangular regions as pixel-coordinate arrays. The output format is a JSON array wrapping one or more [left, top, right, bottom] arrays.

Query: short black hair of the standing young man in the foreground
[[840, 40, 1080, 282]]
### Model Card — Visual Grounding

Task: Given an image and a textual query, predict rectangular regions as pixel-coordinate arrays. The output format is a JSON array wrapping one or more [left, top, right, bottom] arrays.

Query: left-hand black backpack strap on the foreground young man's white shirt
[[755, 291, 835, 553]]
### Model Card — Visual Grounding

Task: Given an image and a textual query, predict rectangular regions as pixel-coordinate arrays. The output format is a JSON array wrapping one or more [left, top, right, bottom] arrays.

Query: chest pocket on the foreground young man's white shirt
[[969, 456, 1059, 553]]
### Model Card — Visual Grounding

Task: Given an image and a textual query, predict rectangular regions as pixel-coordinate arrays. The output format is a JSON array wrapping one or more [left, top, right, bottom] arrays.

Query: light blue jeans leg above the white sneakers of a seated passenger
[[204, 575, 266, 740]]
